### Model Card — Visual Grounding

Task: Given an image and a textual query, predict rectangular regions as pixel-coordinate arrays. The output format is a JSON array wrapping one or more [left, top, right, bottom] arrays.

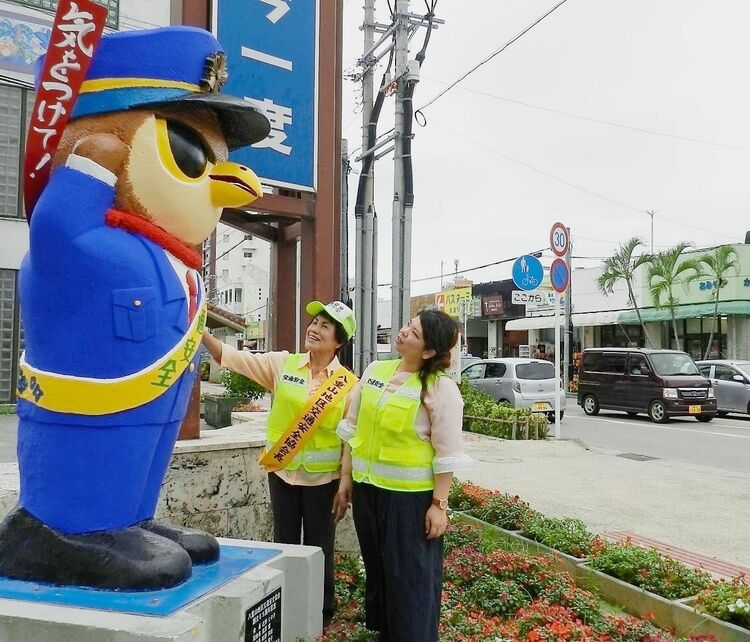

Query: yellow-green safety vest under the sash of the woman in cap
[[266, 354, 346, 473]]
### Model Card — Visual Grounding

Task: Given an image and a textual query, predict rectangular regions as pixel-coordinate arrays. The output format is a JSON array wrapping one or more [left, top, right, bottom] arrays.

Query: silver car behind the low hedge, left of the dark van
[[461, 359, 565, 421]]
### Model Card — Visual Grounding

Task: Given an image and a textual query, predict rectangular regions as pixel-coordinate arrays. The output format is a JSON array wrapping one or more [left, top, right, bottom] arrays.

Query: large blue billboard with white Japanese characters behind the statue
[[213, 0, 318, 191]]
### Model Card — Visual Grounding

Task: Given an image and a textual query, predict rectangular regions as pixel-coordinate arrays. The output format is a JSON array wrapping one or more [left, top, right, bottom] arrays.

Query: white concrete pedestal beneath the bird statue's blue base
[[0, 539, 323, 642]]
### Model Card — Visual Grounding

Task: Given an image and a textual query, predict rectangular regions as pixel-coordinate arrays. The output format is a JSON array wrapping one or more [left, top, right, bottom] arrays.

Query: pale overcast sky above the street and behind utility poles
[[342, 0, 750, 298]]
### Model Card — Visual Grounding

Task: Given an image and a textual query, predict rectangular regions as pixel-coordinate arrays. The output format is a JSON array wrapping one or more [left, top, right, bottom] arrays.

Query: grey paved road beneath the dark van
[[560, 399, 750, 473]]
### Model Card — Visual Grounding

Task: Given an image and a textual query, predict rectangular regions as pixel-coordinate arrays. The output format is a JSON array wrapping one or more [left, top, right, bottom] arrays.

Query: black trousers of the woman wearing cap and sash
[[268, 473, 339, 621]]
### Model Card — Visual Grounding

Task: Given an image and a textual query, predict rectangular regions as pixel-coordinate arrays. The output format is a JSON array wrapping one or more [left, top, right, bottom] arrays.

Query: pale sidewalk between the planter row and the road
[[458, 433, 750, 566]]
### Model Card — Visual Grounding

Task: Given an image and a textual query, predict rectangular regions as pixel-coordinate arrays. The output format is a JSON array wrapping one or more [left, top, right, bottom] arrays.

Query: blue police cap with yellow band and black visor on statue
[[37, 27, 270, 149]]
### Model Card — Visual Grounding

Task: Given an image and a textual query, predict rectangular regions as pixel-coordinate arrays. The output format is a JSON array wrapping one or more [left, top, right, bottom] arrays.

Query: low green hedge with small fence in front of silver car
[[459, 379, 549, 439]]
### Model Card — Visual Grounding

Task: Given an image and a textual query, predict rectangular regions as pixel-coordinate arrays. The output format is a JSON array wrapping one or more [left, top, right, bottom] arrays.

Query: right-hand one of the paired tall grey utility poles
[[391, 0, 411, 356]]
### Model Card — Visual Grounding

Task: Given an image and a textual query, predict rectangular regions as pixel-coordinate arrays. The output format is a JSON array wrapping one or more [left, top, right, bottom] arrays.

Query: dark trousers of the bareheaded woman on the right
[[352, 482, 443, 642]]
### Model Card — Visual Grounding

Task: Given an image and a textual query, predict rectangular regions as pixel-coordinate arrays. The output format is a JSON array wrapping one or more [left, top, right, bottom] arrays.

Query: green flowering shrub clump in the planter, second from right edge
[[590, 541, 711, 600]]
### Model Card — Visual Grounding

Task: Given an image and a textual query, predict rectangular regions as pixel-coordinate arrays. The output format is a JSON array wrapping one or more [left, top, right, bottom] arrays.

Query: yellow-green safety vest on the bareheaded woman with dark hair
[[349, 359, 441, 492]]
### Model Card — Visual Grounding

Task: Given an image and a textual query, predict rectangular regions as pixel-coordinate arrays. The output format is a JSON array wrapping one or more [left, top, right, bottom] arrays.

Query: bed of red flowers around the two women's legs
[[320, 524, 712, 642]]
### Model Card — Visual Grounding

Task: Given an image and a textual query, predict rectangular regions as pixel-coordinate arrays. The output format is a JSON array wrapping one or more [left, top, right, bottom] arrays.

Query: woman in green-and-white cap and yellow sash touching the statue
[[203, 301, 357, 625]]
